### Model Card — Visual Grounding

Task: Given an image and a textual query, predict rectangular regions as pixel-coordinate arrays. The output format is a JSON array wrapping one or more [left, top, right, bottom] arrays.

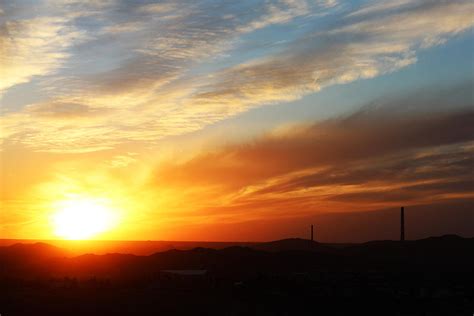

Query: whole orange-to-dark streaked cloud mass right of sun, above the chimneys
[[150, 89, 474, 222]]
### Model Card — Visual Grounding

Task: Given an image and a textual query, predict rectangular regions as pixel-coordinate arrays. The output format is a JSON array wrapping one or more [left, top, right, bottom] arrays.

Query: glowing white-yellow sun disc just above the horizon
[[52, 198, 116, 240]]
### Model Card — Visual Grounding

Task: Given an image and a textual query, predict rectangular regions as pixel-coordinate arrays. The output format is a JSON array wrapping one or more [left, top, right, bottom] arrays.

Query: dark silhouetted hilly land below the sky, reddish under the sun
[[0, 235, 474, 315]]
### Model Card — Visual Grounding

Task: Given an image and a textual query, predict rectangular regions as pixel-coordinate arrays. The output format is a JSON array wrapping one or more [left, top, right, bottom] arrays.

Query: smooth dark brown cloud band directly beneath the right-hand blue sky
[[156, 110, 474, 189]]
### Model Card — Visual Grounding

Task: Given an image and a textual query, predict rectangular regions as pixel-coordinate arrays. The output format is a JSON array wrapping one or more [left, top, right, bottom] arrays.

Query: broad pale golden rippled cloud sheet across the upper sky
[[0, 1, 473, 152]]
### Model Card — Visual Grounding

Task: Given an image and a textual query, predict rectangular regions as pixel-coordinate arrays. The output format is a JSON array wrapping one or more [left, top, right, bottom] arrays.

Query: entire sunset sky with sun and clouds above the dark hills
[[0, 0, 474, 242]]
